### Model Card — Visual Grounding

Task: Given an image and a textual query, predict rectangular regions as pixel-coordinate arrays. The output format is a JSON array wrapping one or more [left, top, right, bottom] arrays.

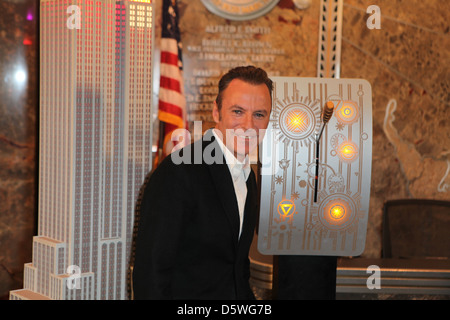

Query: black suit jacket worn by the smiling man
[[133, 130, 258, 300]]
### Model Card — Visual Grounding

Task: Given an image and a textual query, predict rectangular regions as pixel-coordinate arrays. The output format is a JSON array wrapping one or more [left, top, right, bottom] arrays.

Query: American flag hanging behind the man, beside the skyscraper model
[[156, 0, 189, 162]]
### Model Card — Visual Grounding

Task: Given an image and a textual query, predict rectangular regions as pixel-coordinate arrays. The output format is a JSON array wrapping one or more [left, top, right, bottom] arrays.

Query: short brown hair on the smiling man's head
[[216, 66, 273, 111]]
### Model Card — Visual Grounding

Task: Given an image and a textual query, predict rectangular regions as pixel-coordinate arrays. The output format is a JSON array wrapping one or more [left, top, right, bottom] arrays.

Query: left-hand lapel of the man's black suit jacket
[[203, 134, 243, 246]]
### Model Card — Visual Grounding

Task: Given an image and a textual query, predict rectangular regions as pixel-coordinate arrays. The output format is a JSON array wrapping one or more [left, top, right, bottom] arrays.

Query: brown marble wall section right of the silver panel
[[341, 0, 450, 257]]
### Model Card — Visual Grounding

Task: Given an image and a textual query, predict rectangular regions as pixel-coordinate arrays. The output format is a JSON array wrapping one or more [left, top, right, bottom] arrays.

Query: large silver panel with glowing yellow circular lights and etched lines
[[258, 77, 372, 256]]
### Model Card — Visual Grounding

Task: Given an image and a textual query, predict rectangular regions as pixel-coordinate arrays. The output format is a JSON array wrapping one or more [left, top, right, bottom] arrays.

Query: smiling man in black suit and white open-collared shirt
[[133, 66, 272, 299]]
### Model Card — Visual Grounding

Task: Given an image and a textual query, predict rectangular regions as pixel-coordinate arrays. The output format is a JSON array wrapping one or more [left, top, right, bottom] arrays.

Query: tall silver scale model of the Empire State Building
[[10, 0, 154, 300]]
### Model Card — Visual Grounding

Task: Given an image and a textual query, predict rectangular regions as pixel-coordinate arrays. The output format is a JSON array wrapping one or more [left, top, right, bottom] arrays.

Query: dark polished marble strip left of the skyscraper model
[[0, 0, 39, 298]]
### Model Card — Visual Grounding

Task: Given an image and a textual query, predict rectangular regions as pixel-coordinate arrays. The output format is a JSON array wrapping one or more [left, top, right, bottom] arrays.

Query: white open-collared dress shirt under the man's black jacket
[[213, 129, 251, 237]]
